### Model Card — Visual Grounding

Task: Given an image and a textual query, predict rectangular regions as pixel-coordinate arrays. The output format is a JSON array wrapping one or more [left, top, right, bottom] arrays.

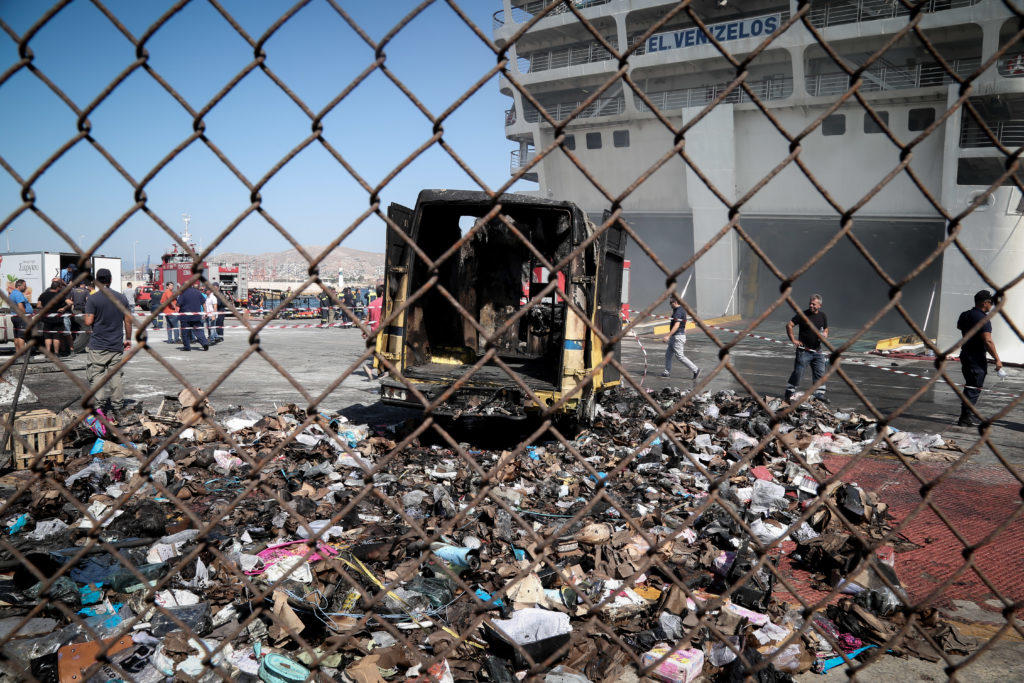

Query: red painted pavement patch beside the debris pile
[[778, 456, 1024, 608]]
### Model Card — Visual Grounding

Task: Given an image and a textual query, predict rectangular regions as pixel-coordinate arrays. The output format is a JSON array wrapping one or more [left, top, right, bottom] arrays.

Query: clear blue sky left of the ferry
[[0, 0, 534, 267]]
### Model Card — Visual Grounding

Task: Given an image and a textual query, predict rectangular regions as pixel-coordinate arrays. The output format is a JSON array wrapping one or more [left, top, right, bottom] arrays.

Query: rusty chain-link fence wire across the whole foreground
[[0, 0, 1024, 680]]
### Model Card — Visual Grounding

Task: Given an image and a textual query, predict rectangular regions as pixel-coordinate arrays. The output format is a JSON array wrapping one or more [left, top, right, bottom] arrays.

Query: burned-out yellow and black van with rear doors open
[[377, 189, 626, 421]]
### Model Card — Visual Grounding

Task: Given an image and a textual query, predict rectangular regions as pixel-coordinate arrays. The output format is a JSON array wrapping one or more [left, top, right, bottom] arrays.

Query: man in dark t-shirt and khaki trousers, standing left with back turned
[[85, 268, 132, 414]]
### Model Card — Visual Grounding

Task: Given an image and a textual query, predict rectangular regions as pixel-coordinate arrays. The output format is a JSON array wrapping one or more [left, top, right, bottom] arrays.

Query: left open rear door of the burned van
[[374, 204, 416, 368]]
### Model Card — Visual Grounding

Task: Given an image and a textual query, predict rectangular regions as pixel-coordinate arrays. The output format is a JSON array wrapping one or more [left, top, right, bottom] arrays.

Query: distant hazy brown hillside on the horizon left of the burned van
[[213, 245, 384, 281]]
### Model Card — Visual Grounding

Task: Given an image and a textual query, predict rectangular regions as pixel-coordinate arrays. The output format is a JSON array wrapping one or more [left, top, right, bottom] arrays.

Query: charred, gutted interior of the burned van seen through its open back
[[404, 197, 573, 388]]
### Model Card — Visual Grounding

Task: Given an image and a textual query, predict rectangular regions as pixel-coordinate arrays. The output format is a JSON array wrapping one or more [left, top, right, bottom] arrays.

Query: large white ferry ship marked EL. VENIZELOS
[[494, 0, 1024, 362]]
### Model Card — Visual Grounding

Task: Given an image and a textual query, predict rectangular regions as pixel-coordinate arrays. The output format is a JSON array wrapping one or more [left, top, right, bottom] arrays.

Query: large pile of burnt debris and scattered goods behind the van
[[0, 389, 976, 682]]
